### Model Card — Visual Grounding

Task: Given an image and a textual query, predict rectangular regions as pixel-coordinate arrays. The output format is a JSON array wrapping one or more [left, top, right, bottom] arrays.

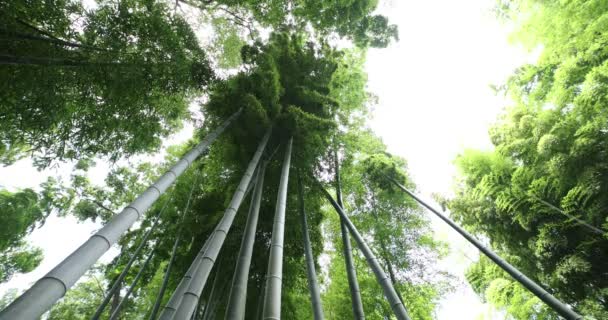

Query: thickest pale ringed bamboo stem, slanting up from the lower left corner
[[0, 109, 242, 320]]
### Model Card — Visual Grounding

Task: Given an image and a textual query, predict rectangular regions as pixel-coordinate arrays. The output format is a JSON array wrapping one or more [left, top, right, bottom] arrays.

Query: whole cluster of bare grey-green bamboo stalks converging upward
[[0, 110, 582, 320]]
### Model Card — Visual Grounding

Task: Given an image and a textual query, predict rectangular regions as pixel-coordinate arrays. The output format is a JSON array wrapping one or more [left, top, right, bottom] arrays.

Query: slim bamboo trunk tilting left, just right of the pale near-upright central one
[[298, 172, 324, 320]]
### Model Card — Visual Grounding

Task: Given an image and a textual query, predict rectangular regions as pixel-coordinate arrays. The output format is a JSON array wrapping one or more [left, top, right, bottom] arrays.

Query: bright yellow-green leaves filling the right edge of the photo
[[450, 1, 608, 319]]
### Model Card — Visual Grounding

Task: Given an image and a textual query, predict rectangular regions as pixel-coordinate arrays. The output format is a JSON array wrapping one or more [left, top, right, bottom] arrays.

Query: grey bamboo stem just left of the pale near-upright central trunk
[[226, 161, 266, 320]]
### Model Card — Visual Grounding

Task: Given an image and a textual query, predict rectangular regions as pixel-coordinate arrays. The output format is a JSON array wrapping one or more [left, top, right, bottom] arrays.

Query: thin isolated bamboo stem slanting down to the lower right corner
[[387, 177, 583, 319]]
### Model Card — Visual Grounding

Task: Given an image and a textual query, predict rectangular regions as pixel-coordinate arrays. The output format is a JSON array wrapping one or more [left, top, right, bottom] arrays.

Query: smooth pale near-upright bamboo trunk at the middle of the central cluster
[[262, 138, 293, 319]]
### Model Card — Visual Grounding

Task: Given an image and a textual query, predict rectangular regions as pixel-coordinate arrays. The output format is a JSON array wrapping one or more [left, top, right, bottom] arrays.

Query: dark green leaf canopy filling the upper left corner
[[0, 0, 213, 167]]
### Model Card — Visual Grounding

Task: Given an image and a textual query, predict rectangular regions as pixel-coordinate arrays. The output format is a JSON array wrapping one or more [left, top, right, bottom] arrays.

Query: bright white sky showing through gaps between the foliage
[[0, 0, 533, 319]]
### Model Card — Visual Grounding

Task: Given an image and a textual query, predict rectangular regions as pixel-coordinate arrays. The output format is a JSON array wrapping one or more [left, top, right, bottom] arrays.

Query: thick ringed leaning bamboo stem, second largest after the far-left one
[[174, 129, 271, 320]]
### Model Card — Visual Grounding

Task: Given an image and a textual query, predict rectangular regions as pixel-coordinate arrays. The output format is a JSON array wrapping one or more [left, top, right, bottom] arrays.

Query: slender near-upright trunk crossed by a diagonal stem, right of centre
[[334, 149, 365, 320]]
